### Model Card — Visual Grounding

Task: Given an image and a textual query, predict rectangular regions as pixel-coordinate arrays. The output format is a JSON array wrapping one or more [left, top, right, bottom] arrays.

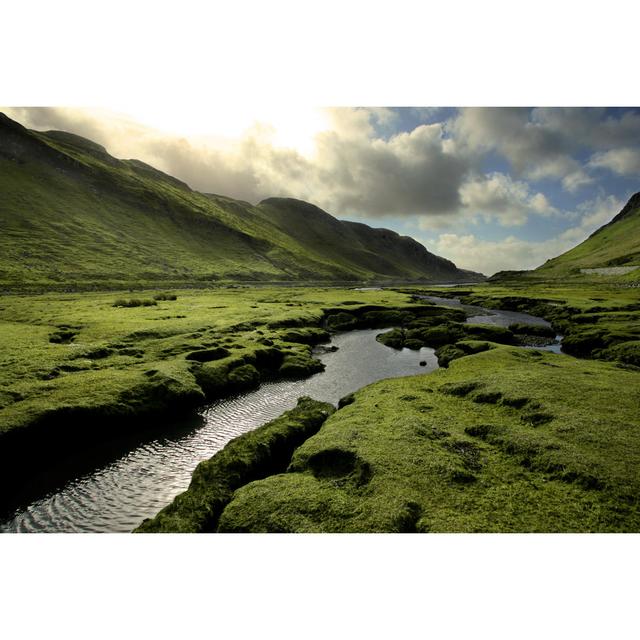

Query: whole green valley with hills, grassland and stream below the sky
[[0, 114, 640, 533]]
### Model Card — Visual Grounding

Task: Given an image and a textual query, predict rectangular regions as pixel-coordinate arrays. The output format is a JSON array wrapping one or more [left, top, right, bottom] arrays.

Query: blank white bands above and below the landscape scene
[[0, 0, 640, 639]]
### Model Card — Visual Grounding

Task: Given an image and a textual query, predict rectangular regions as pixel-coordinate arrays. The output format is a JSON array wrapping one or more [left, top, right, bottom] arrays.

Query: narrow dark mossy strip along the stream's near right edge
[[136, 398, 334, 533]]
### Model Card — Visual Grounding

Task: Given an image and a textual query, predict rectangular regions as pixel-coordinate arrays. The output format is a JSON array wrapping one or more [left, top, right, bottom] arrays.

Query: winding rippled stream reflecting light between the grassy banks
[[0, 298, 559, 532]]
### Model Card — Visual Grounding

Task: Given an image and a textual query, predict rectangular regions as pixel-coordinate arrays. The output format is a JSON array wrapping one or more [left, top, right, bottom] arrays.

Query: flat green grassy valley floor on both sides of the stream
[[0, 285, 640, 531]]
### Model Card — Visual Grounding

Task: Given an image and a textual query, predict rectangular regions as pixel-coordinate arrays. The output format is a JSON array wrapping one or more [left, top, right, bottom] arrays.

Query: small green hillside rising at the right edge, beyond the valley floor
[[490, 193, 640, 281]]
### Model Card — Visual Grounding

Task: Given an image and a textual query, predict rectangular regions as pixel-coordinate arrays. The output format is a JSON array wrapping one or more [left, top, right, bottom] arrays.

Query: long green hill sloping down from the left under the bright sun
[[0, 114, 481, 289]]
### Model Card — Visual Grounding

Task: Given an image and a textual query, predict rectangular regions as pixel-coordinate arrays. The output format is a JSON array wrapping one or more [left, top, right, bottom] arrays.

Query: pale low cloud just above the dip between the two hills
[[418, 196, 623, 275]]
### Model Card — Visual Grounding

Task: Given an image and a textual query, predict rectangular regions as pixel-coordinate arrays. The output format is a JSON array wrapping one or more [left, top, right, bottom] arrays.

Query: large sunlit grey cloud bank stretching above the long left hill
[[7, 108, 470, 218]]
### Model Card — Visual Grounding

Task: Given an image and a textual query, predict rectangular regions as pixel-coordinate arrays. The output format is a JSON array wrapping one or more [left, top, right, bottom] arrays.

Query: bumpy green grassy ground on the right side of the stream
[[141, 287, 640, 532]]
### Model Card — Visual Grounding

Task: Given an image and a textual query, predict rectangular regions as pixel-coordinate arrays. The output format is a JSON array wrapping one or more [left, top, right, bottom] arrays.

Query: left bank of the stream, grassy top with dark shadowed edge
[[0, 288, 455, 511]]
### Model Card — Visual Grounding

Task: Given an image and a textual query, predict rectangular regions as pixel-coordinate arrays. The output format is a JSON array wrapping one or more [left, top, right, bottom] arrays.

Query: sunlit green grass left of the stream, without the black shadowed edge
[[0, 288, 436, 437]]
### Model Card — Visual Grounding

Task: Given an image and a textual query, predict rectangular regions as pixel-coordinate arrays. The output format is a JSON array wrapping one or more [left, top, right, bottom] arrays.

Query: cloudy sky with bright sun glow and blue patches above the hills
[[2, 105, 640, 275]]
